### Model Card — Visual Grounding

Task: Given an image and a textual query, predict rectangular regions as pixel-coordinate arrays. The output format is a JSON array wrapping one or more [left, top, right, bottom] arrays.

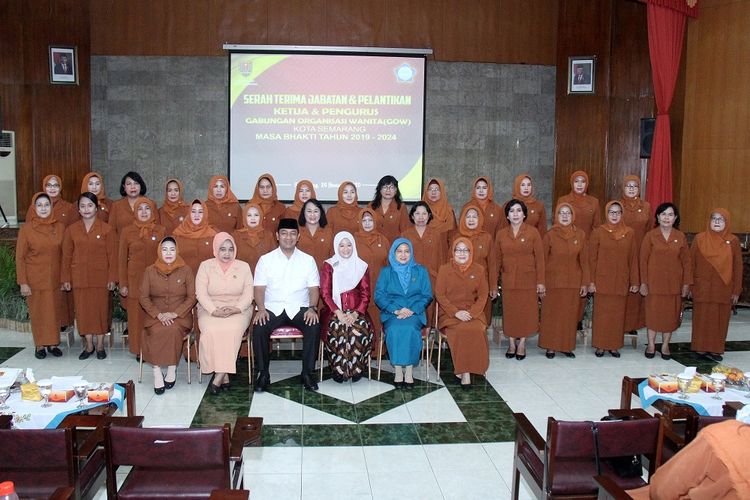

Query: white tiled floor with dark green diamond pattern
[[0, 310, 750, 500]]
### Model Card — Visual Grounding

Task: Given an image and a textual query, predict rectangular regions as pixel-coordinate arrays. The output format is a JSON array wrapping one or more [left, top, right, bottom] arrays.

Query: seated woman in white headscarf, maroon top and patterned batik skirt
[[320, 231, 372, 383]]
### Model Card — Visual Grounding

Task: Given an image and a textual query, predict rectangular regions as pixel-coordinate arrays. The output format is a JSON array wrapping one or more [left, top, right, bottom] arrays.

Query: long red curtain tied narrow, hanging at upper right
[[646, 0, 686, 209]]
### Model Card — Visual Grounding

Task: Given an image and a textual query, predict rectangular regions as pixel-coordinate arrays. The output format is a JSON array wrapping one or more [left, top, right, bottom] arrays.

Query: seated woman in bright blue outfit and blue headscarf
[[375, 238, 432, 389]]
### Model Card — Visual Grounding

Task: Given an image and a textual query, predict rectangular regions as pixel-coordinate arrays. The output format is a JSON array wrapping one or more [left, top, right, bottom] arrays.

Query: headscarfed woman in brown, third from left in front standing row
[[118, 198, 165, 356]]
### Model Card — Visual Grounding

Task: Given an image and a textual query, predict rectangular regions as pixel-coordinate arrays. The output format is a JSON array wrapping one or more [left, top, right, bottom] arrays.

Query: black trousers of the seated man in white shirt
[[253, 307, 320, 374]]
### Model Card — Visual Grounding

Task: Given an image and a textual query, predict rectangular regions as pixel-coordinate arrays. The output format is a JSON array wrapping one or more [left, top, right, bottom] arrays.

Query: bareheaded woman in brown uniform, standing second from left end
[[60, 193, 117, 359]]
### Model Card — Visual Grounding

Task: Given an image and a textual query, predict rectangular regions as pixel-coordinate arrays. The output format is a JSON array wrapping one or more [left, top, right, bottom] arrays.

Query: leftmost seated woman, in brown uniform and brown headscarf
[[140, 236, 195, 394]]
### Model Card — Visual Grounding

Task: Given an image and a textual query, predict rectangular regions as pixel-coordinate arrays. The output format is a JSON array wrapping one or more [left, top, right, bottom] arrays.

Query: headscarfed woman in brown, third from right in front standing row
[[589, 201, 638, 358]]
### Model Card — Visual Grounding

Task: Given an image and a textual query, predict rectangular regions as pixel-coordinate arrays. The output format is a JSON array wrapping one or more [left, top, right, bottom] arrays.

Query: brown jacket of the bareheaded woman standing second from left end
[[60, 219, 117, 288]]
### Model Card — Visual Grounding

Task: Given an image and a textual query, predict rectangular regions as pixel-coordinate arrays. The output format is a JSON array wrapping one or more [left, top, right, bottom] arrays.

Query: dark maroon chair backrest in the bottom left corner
[[0, 429, 77, 498]]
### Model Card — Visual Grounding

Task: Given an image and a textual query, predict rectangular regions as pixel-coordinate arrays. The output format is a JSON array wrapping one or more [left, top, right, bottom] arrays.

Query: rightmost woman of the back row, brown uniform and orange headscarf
[[620, 175, 651, 335]]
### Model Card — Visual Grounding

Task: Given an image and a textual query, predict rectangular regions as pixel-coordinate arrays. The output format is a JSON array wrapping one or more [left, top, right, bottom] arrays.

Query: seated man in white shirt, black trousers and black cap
[[253, 219, 320, 392]]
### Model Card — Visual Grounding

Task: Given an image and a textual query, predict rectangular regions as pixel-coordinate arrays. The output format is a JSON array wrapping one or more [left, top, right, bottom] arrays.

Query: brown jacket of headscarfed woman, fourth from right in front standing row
[[542, 226, 591, 289]]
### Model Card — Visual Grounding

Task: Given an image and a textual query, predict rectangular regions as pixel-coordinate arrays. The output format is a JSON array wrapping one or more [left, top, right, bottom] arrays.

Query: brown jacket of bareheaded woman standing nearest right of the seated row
[[495, 223, 545, 290]]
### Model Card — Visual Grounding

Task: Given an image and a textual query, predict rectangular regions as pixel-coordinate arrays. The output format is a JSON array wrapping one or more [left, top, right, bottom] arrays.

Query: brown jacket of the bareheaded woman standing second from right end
[[639, 227, 693, 295]]
